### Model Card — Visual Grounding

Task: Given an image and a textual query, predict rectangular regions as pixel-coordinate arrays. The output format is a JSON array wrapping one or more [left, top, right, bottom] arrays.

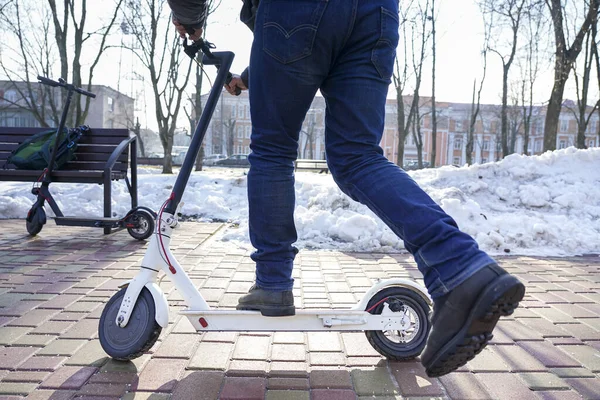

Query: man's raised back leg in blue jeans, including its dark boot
[[321, 0, 524, 376]]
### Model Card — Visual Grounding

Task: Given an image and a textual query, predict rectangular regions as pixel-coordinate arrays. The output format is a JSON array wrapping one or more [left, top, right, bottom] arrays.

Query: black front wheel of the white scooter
[[98, 288, 162, 360]]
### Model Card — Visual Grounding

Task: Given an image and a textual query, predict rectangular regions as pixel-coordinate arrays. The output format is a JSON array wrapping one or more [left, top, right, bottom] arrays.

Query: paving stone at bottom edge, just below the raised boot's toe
[[390, 362, 444, 397]]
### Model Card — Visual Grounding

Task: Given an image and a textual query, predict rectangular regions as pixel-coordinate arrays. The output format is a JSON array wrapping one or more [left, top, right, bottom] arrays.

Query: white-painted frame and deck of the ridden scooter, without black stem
[[115, 211, 432, 332]]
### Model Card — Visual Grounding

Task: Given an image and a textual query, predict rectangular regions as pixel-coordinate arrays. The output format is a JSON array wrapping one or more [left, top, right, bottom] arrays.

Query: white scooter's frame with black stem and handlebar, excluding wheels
[[115, 39, 432, 332]]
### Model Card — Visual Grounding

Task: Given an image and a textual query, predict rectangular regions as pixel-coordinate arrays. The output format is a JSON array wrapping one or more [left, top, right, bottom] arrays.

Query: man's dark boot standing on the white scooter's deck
[[236, 284, 296, 317]]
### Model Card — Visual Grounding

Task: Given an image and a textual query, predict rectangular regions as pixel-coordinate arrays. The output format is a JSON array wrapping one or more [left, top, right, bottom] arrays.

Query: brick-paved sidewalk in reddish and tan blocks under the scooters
[[0, 220, 600, 400]]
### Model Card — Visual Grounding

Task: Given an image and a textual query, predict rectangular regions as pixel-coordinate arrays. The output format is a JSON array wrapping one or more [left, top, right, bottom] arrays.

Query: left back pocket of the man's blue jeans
[[261, 0, 327, 64]]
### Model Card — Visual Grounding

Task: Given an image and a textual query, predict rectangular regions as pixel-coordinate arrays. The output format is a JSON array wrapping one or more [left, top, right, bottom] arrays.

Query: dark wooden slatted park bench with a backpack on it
[[0, 127, 138, 233]]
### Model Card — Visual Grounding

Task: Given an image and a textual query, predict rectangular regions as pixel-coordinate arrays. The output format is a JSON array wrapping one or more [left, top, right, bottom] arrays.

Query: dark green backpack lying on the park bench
[[5, 125, 90, 170]]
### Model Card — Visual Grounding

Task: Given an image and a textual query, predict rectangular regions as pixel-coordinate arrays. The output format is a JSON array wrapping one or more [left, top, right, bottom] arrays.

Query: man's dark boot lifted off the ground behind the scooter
[[421, 264, 525, 377]]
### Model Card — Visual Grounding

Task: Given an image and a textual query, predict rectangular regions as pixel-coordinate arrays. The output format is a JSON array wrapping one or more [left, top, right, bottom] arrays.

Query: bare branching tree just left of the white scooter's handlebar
[[125, 0, 192, 174]]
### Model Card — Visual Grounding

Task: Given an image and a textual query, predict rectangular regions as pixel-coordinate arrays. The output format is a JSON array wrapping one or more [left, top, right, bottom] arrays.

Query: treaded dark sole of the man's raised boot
[[425, 274, 525, 378]]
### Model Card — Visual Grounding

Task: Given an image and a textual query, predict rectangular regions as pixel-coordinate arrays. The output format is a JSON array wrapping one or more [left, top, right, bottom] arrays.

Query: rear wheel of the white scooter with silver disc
[[365, 286, 431, 361]]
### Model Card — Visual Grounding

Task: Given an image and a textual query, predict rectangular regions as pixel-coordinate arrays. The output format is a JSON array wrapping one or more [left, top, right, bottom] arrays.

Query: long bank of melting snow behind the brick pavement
[[0, 147, 600, 256]]
